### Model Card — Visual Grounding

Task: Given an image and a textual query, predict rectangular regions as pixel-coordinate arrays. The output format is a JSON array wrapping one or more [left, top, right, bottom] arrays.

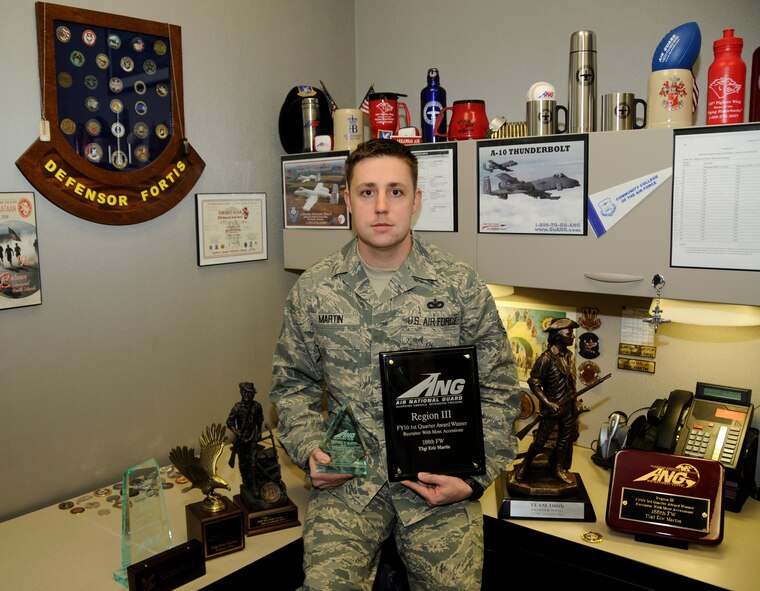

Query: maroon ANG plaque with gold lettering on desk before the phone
[[607, 449, 724, 547]]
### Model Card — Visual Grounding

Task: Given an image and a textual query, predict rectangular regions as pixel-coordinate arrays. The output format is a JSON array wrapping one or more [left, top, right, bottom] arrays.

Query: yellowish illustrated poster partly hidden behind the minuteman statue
[[496, 302, 577, 387]]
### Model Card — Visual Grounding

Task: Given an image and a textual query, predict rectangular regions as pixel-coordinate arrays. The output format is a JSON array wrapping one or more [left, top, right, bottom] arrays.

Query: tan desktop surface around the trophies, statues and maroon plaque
[[0, 448, 760, 591]]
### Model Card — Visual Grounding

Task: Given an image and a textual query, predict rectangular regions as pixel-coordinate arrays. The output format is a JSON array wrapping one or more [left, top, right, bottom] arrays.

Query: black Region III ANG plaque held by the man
[[380, 345, 485, 482]]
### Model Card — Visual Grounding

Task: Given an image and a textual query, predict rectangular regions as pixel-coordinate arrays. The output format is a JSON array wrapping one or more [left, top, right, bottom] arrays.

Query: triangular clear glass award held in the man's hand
[[317, 401, 368, 476]]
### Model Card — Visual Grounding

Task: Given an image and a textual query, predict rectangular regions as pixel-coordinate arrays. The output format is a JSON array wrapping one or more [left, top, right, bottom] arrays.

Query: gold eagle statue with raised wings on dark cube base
[[169, 424, 245, 559]]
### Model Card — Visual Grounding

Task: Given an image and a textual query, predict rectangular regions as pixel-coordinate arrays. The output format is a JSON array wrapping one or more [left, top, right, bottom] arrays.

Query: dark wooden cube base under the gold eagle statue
[[185, 499, 245, 560]]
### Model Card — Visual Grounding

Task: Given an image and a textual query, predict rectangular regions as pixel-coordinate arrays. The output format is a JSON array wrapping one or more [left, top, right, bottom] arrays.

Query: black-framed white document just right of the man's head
[[407, 142, 459, 232]]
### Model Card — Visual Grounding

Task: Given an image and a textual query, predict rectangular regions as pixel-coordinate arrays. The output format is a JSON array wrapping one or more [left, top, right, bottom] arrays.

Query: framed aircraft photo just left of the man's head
[[282, 151, 351, 230]]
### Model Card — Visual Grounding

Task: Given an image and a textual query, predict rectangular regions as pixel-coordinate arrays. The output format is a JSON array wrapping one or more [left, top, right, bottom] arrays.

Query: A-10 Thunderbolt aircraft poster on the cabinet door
[[478, 134, 588, 236]]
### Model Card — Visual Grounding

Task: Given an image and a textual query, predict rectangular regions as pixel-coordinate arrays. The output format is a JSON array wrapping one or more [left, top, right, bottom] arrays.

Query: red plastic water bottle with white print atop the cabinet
[[707, 29, 747, 125]]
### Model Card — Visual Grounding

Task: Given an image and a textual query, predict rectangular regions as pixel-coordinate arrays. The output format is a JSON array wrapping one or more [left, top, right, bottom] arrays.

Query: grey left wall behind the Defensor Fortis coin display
[[0, 0, 355, 519]]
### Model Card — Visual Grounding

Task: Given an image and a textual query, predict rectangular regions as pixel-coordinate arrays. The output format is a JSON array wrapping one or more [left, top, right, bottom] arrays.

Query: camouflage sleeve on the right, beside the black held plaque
[[461, 274, 520, 488]]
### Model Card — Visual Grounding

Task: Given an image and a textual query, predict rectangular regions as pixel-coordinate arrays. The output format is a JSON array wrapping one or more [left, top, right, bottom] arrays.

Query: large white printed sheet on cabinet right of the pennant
[[670, 125, 760, 271]]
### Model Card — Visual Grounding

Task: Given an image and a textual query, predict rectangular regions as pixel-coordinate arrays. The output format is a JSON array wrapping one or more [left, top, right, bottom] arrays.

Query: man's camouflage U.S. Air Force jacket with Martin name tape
[[270, 234, 519, 525]]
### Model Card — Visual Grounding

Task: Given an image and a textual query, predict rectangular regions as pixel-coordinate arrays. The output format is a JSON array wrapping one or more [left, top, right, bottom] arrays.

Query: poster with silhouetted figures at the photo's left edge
[[0, 193, 42, 310]]
